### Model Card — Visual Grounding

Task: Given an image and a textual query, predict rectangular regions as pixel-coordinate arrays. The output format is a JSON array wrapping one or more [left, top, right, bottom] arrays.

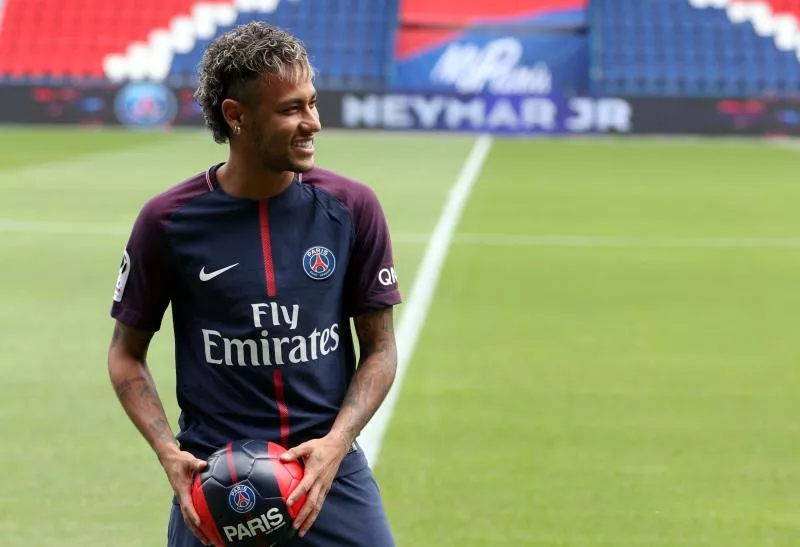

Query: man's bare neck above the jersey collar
[[217, 154, 295, 200]]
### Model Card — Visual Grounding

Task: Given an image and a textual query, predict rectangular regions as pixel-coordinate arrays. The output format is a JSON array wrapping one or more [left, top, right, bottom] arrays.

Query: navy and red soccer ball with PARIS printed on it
[[192, 439, 306, 547]]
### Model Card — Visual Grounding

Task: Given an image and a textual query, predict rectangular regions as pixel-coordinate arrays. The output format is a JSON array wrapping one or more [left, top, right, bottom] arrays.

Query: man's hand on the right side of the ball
[[281, 434, 349, 537]]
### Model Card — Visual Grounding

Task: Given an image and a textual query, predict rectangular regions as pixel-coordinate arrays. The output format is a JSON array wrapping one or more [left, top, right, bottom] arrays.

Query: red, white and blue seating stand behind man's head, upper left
[[0, 0, 397, 89]]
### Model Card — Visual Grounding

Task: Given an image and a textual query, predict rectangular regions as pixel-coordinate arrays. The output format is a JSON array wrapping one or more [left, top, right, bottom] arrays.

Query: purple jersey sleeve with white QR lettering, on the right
[[348, 187, 402, 316]]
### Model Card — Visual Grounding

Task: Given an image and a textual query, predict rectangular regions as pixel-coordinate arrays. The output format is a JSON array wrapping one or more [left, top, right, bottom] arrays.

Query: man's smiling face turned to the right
[[246, 71, 322, 173]]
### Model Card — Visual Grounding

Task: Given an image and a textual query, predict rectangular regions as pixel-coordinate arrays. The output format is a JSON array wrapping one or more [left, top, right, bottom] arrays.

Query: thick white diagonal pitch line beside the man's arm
[[358, 135, 492, 467]]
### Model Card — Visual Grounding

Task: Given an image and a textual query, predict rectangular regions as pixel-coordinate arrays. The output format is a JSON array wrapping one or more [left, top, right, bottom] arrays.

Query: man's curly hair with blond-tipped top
[[194, 21, 314, 144]]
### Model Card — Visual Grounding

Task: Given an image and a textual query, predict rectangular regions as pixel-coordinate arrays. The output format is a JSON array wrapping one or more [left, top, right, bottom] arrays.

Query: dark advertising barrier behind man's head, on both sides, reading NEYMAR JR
[[0, 84, 800, 136]]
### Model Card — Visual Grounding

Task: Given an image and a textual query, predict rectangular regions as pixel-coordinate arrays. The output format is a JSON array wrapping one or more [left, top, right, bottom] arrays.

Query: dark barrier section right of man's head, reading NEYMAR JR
[[331, 93, 800, 136]]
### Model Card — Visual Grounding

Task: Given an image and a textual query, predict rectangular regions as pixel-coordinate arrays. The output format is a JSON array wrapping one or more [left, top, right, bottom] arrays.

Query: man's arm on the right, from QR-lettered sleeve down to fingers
[[281, 184, 401, 537]]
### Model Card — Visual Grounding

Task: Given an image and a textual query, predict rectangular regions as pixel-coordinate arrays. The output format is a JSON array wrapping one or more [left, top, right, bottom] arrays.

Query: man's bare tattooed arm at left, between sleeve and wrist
[[108, 321, 179, 460]]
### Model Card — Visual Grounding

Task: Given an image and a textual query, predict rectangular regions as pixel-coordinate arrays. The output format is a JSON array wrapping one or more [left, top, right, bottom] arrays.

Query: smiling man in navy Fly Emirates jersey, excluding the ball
[[108, 23, 400, 547]]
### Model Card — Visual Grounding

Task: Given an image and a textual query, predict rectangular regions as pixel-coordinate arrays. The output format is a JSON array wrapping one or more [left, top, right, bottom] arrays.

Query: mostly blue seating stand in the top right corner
[[590, 0, 800, 96]]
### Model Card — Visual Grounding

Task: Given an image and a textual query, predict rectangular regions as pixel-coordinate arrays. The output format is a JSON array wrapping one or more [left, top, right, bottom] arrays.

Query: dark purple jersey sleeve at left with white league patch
[[111, 201, 171, 332]]
